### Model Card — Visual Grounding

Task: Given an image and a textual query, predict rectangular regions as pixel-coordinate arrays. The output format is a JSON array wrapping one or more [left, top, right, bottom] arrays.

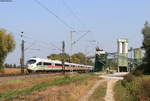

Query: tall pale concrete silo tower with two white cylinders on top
[[117, 39, 128, 72]]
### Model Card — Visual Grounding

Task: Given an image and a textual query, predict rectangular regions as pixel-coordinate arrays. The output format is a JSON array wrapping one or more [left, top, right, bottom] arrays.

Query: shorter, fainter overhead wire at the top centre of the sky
[[62, 0, 85, 25]]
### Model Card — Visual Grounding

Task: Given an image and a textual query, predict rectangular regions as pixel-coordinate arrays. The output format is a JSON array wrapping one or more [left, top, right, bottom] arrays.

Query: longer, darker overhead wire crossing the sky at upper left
[[34, 0, 74, 29]]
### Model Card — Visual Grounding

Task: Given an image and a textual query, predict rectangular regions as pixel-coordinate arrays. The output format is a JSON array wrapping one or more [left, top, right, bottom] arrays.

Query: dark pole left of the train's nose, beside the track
[[20, 32, 24, 74]]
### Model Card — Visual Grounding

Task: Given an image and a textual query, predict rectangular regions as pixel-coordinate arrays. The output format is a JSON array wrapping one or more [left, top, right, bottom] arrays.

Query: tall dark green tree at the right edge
[[136, 21, 150, 74]]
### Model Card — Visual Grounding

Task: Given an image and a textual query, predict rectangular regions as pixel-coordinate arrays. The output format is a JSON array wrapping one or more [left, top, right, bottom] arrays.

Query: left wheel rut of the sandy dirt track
[[79, 80, 105, 101]]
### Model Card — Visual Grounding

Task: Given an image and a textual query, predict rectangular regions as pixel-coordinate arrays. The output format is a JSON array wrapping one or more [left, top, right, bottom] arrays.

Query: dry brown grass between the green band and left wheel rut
[[11, 72, 98, 101]]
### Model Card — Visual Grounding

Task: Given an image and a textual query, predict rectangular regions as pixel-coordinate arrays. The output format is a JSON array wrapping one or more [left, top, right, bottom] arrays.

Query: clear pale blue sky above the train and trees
[[0, 0, 150, 64]]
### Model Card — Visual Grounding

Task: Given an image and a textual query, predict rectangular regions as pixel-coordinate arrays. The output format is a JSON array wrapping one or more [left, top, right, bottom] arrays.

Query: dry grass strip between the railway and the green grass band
[[0, 74, 62, 94]]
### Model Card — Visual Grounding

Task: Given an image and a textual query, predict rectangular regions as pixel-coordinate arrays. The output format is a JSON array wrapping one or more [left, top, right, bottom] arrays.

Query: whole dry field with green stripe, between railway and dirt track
[[0, 73, 105, 101]]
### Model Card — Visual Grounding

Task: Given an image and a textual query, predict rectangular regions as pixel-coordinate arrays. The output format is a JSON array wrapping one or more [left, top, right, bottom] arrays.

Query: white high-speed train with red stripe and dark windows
[[27, 58, 94, 72]]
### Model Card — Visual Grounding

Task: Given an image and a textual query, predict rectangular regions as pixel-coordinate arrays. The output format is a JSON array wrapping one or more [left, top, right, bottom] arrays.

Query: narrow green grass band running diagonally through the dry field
[[0, 74, 94, 100]]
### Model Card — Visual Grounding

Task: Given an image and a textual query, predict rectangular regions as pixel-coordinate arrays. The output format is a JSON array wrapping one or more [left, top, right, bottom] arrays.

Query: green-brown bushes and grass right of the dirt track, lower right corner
[[114, 74, 150, 101]]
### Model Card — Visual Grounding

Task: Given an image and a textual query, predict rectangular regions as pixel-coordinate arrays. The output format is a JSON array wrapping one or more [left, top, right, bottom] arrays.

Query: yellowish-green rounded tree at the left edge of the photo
[[0, 29, 16, 71]]
